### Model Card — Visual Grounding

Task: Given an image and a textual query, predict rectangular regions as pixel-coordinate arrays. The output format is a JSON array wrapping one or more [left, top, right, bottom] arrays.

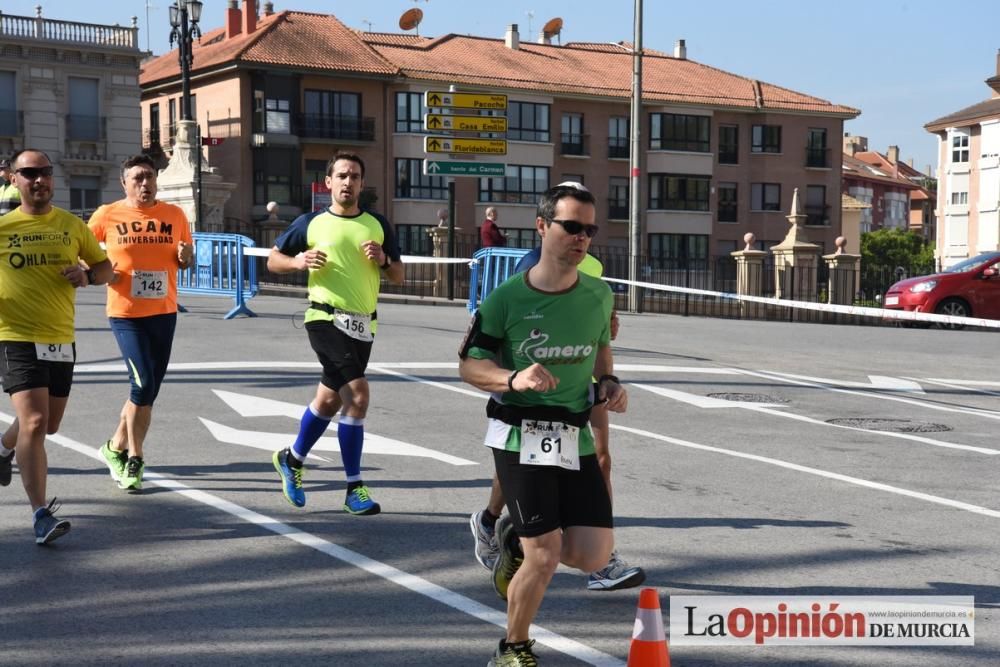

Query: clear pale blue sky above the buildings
[[7, 0, 1000, 170]]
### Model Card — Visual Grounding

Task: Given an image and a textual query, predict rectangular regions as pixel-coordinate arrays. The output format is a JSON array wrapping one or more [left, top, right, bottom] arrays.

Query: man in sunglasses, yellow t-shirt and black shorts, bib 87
[[0, 149, 112, 544]]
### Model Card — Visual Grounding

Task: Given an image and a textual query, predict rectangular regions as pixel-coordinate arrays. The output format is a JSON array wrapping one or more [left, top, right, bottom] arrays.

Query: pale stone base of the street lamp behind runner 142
[[156, 120, 236, 232]]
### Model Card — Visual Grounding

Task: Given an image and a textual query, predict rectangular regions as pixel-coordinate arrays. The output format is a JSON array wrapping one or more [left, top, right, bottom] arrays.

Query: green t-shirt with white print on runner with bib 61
[[468, 272, 614, 456]]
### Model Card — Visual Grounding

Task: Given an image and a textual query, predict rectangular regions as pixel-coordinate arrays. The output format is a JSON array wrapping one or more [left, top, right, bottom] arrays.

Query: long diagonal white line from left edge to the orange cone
[[0, 412, 625, 667]]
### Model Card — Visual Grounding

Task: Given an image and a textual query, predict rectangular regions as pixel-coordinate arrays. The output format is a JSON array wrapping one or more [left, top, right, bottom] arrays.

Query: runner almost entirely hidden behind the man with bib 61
[[469, 181, 646, 591]]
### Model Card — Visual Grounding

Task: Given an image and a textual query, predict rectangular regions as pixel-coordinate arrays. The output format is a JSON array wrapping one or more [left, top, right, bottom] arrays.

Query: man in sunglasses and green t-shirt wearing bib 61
[[459, 185, 628, 667]]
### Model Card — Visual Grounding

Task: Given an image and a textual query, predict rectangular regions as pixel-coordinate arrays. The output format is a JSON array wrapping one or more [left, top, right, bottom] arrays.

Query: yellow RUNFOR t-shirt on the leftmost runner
[[0, 207, 108, 343]]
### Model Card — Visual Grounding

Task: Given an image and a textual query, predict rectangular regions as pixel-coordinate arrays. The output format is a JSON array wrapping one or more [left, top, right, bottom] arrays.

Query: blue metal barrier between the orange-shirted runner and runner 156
[[177, 232, 259, 320]]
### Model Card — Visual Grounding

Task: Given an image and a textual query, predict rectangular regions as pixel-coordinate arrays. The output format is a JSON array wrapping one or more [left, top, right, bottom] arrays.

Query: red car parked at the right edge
[[882, 252, 1000, 328]]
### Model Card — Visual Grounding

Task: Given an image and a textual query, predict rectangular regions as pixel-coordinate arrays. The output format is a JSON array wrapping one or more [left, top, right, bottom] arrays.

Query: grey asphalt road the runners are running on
[[0, 290, 1000, 667]]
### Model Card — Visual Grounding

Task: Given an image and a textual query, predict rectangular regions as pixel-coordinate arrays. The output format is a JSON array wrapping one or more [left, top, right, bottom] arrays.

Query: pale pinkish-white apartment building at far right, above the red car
[[924, 51, 1000, 266]]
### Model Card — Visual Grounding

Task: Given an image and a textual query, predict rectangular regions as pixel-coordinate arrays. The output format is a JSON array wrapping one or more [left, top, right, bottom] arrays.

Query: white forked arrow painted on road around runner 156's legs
[[205, 389, 478, 466]]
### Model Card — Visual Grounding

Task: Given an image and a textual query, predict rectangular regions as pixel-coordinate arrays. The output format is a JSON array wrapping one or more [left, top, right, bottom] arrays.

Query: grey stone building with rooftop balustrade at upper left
[[0, 6, 146, 216]]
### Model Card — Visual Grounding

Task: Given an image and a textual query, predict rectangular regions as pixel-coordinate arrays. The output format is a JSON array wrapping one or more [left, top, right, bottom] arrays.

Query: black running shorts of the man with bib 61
[[493, 449, 614, 537]]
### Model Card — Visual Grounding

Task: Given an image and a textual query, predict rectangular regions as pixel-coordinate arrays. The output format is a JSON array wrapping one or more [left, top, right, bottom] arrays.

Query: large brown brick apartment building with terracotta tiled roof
[[140, 0, 859, 258]]
